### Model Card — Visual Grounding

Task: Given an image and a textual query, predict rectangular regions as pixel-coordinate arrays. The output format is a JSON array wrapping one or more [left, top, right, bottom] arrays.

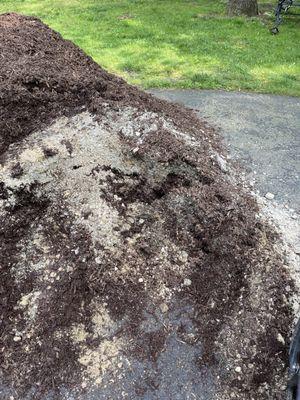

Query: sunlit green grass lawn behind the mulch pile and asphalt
[[0, 0, 300, 96]]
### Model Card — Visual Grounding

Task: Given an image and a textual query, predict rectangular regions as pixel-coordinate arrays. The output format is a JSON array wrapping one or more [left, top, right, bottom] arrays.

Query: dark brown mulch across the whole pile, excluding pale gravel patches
[[0, 14, 292, 399]]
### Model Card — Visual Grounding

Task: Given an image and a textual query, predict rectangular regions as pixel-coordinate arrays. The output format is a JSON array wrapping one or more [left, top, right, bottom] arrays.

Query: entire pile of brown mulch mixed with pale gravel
[[0, 14, 294, 400]]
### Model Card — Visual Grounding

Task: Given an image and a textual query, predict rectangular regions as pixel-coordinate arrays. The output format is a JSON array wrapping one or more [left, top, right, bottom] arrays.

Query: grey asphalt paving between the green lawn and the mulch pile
[[150, 90, 300, 212]]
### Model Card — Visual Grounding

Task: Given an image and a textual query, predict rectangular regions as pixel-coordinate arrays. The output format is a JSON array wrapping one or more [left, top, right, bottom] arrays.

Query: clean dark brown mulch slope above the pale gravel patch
[[0, 14, 217, 159]]
